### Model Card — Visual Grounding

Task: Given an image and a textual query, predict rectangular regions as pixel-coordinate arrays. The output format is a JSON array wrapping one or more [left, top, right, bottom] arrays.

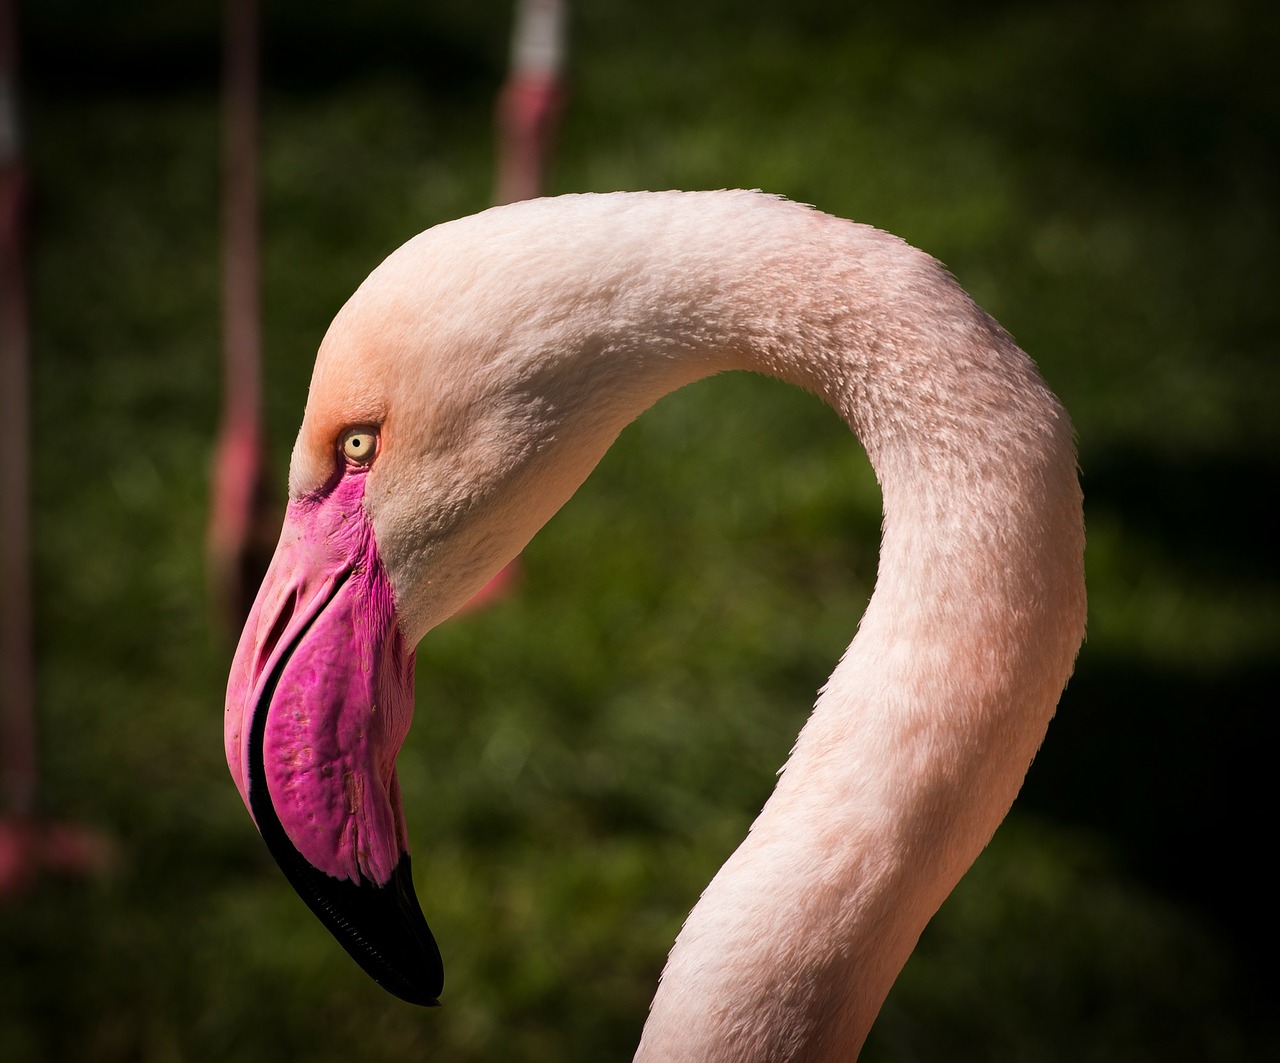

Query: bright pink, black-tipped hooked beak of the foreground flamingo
[[225, 469, 444, 1005]]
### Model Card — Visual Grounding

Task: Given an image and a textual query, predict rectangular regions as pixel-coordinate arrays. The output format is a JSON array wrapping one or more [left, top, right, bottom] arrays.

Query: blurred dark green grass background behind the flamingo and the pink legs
[[0, 0, 1280, 1063]]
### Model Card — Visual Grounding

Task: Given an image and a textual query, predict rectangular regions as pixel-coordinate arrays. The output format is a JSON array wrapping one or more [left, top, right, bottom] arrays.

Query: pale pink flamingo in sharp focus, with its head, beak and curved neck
[[225, 191, 1085, 1063]]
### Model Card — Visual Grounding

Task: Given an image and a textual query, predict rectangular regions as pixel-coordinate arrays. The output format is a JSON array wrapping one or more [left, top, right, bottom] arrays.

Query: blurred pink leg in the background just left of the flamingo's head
[[207, 0, 280, 633]]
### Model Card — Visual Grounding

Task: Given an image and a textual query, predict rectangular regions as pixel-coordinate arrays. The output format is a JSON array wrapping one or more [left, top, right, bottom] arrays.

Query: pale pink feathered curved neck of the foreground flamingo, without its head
[[514, 195, 1084, 1063]]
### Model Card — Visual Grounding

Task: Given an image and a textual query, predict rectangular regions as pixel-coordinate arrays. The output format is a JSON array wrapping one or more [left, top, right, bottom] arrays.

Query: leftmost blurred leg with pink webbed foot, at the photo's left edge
[[0, 0, 111, 900]]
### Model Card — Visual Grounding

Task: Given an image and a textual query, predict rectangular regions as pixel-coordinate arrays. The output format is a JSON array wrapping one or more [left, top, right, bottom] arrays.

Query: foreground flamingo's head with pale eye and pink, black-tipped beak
[[225, 207, 655, 1004]]
